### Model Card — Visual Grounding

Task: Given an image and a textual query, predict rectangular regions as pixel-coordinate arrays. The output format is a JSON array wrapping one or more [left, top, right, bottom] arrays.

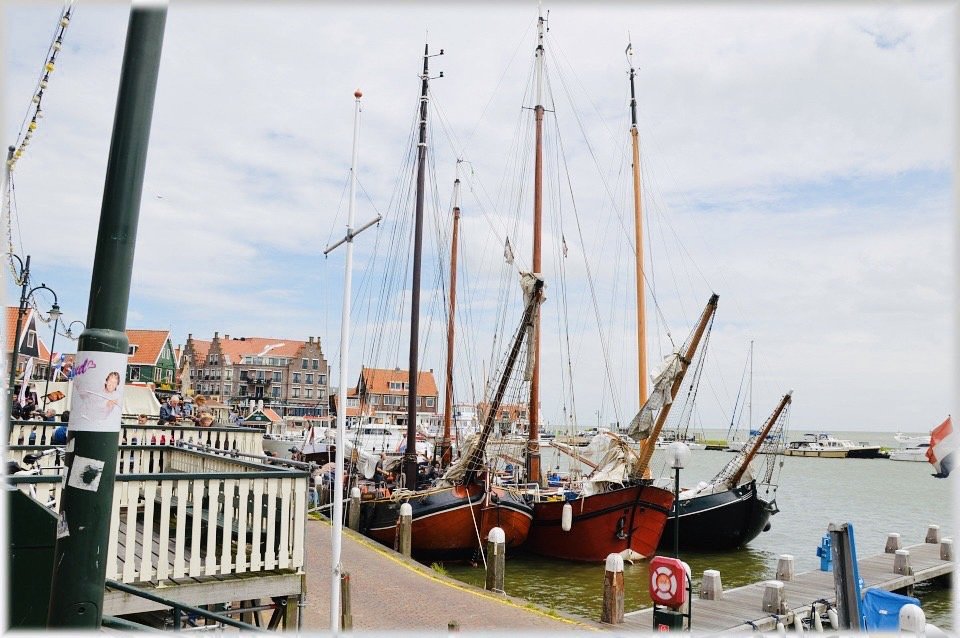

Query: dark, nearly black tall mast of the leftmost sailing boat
[[403, 44, 443, 490]]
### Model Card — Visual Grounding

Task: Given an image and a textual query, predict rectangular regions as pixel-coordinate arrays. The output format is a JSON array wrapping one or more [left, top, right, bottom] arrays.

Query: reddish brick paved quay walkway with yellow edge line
[[303, 520, 603, 634]]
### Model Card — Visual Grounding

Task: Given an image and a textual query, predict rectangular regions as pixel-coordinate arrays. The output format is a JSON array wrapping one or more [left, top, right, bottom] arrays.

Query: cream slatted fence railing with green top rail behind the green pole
[[8, 446, 309, 583]]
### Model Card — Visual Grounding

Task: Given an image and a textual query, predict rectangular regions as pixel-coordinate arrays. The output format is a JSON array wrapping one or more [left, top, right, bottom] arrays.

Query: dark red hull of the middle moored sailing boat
[[524, 484, 673, 562]]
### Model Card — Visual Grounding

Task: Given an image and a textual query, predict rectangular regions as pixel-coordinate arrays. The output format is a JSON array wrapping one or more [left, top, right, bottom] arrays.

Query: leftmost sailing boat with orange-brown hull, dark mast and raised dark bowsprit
[[360, 46, 543, 560]]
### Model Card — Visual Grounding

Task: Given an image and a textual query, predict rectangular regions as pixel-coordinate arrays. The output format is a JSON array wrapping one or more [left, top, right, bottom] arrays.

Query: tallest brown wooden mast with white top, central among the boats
[[526, 5, 544, 490]]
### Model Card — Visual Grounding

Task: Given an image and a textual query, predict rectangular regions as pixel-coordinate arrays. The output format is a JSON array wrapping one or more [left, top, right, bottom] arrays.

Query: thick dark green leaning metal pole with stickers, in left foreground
[[47, 3, 167, 629]]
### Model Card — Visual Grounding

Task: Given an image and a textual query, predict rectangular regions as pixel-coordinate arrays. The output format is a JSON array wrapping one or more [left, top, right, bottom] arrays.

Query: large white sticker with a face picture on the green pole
[[70, 351, 127, 432]]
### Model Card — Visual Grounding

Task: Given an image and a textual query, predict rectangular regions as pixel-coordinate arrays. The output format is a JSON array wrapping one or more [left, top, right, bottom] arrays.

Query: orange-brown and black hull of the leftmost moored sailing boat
[[360, 484, 533, 560]]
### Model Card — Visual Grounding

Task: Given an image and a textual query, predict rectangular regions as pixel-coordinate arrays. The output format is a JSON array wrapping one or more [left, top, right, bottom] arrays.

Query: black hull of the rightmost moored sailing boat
[[660, 481, 776, 551]]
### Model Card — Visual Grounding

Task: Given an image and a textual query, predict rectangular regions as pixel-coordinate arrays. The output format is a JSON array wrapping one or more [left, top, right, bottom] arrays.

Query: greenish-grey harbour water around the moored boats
[[444, 432, 954, 629]]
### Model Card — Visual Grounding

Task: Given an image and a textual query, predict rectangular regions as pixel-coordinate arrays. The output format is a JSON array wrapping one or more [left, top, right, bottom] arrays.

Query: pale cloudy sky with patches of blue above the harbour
[[0, 2, 956, 432]]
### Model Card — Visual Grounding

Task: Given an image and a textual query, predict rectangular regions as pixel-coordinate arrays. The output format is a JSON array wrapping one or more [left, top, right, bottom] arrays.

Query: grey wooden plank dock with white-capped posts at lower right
[[616, 539, 955, 635]]
